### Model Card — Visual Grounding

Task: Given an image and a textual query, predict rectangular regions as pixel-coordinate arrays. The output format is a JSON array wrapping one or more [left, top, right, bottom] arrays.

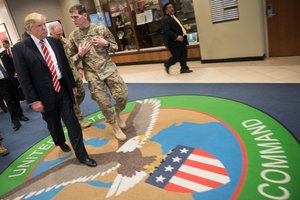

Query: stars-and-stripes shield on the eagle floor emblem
[[146, 145, 230, 193]]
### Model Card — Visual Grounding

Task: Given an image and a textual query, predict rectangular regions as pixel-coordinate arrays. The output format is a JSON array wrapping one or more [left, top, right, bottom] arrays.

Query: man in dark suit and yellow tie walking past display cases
[[162, 3, 193, 74]]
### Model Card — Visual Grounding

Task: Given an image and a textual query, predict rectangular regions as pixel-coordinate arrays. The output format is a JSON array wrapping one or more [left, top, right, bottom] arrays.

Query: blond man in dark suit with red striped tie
[[13, 13, 97, 167]]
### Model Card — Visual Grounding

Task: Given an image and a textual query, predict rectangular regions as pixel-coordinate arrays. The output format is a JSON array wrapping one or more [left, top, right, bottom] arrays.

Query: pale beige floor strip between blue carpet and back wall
[[118, 56, 300, 83]]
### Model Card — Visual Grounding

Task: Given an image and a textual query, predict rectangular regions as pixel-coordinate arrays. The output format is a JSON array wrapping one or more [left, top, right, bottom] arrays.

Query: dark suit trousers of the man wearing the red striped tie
[[42, 81, 88, 161]]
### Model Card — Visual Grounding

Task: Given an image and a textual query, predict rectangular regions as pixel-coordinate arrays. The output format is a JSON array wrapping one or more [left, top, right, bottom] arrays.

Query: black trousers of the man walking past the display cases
[[165, 43, 189, 70]]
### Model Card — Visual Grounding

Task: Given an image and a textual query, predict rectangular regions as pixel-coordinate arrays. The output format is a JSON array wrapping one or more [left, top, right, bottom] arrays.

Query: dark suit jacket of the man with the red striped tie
[[13, 37, 76, 111]]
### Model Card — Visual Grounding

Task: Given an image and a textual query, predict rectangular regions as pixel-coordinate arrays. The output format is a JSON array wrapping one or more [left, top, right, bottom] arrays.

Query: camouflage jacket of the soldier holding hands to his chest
[[67, 23, 118, 80]]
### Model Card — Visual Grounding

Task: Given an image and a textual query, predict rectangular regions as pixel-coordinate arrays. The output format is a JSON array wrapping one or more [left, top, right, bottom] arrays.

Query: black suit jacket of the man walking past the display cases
[[161, 14, 188, 47]]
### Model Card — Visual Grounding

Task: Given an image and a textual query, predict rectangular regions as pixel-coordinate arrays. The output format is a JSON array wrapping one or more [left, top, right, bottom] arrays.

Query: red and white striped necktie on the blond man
[[40, 40, 60, 92]]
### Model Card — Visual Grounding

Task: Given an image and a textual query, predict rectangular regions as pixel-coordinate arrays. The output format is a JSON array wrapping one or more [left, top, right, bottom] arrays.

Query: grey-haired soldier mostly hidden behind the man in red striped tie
[[49, 21, 91, 128]]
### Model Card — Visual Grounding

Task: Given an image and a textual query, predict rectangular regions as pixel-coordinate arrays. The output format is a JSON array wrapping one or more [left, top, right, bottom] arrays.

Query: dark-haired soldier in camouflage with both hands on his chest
[[68, 4, 128, 141]]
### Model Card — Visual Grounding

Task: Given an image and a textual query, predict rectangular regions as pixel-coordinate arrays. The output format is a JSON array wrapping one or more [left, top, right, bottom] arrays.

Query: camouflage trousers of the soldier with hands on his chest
[[88, 71, 128, 124]]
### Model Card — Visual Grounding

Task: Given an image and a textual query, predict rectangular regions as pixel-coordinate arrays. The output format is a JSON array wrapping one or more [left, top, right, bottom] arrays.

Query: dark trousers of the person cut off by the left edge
[[0, 79, 23, 123]]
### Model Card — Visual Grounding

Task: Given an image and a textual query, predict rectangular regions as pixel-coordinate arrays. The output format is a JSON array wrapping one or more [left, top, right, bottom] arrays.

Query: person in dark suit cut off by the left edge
[[0, 57, 29, 131]]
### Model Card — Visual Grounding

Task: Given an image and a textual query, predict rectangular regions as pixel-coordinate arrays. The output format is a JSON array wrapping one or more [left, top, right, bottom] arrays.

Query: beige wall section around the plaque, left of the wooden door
[[193, 0, 266, 60]]
